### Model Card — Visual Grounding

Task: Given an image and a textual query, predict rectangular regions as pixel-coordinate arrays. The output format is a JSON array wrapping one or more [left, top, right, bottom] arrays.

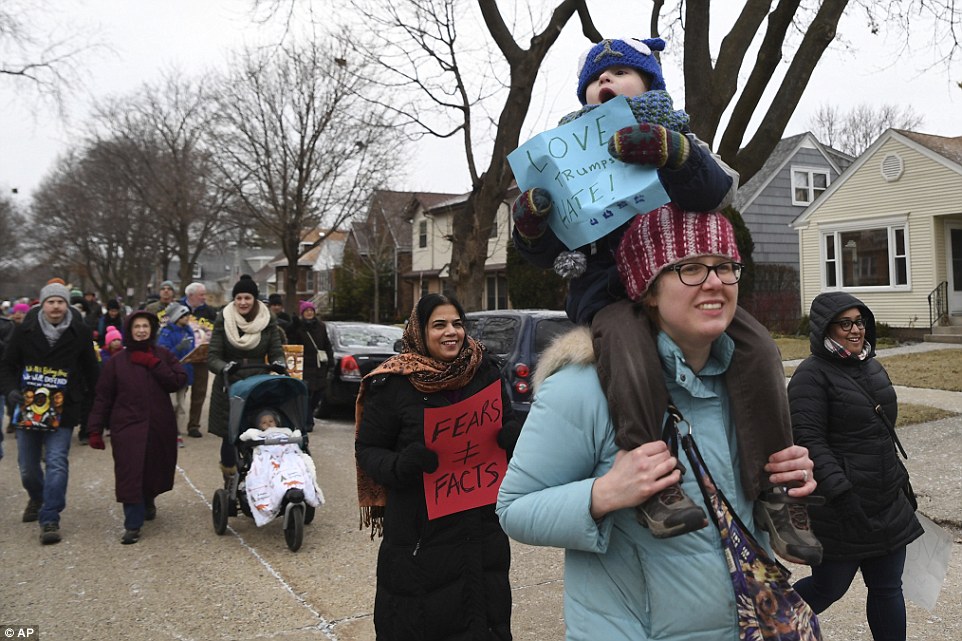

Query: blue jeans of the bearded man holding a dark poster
[[17, 427, 73, 525]]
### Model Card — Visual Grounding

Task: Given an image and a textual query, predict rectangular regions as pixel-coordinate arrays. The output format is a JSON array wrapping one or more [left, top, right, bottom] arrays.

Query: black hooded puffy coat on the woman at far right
[[788, 292, 922, 560]]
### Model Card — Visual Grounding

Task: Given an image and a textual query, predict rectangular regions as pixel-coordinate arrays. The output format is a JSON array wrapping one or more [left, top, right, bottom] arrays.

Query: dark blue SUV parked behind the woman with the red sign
[[465, 309, 574, 421]]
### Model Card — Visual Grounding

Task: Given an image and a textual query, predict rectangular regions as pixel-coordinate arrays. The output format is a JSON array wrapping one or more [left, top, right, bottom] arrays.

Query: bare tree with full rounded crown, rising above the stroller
[[208, 41, 401, 311]]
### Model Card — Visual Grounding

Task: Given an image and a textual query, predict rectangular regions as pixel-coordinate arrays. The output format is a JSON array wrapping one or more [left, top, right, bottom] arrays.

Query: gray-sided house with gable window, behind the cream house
[[733, 132, 855, 272]]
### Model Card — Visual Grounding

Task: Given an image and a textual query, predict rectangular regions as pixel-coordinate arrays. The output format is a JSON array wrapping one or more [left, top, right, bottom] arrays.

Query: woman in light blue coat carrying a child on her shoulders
[[497, 207, 815, 641]]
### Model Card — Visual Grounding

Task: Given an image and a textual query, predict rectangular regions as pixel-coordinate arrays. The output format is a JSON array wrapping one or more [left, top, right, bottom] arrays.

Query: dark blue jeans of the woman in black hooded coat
[[794, 547, 906, 641]]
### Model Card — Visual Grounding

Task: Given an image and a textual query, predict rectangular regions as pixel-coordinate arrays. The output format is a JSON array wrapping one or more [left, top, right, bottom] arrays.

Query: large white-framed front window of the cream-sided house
[[824, 223, 909, 288]]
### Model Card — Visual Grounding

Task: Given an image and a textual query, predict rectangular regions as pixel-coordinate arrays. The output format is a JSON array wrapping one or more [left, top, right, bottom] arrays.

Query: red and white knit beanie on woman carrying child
[[615, 203, 741, 302]]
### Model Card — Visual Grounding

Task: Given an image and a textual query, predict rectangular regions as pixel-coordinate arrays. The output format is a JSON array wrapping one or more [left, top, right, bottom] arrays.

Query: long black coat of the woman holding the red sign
[[356, 359, 518, 641]]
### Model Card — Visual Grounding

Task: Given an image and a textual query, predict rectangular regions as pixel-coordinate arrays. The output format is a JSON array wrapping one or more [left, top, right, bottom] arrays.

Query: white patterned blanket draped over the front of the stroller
[[240, 427, 324, 527]]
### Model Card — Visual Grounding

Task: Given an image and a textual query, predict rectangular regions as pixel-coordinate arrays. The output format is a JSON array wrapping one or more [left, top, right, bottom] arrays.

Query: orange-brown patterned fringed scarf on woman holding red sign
[[354, 307, 484, 540]]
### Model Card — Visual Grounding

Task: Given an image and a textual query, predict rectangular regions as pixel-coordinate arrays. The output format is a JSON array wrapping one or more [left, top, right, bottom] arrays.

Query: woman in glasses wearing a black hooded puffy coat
[[788, 292, 922, 641]]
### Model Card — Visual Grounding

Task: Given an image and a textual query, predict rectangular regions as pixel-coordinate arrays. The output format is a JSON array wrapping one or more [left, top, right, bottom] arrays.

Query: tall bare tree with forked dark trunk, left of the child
[[342, 0, 601, 309]]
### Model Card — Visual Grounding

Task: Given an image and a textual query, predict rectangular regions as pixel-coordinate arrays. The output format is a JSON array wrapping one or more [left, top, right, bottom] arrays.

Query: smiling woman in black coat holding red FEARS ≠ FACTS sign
[[355, 294, 521, 641]]
